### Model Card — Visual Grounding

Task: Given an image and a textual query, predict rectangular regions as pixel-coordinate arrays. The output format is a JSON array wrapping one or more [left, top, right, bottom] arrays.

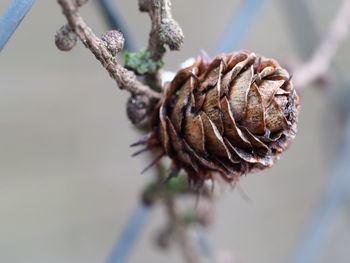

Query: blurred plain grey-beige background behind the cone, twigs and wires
[[0, 0, 350, 263]]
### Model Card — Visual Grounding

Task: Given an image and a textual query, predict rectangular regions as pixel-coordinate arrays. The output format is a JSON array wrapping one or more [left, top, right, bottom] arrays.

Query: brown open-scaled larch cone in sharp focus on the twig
[[148, 51, 299, 185]]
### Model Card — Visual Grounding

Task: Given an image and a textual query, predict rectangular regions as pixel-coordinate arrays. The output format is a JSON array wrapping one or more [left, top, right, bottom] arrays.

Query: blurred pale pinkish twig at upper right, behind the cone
[[293, 0, 350, 90]]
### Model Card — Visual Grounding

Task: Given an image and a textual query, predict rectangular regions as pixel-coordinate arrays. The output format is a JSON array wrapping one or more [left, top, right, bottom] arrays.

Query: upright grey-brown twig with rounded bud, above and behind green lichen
[[139, 0, 184, 89]]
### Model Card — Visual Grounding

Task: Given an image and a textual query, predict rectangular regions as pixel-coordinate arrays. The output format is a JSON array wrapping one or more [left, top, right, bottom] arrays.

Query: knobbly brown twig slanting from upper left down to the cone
[[58, 0, 160, 99]]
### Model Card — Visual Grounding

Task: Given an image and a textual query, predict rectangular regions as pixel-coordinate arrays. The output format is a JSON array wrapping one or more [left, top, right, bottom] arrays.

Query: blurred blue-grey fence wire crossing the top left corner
[[0, 0, 35, 51]]
